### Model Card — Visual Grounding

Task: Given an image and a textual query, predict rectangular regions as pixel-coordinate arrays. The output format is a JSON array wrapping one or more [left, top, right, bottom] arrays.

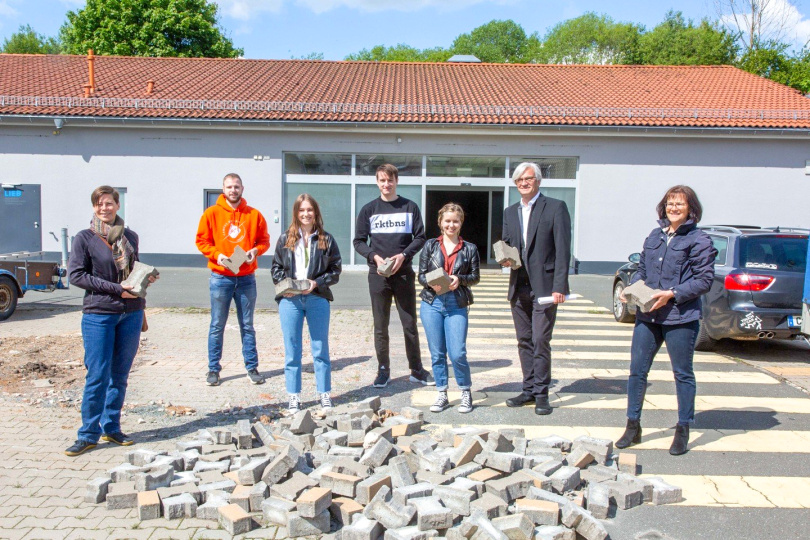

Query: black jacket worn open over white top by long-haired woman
[[272, 233, 343, 302]]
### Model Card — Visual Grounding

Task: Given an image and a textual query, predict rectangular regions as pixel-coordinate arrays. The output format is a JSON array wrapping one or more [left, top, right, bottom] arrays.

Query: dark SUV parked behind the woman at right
[[613, 225, 810, 351]]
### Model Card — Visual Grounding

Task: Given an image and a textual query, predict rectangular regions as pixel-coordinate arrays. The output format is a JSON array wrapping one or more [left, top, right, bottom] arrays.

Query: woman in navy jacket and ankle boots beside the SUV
[[616, 186, 717, 456]]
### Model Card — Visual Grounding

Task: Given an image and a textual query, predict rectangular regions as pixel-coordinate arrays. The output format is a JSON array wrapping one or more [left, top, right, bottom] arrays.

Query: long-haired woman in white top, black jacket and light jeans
[[273, 193, 342, 413]]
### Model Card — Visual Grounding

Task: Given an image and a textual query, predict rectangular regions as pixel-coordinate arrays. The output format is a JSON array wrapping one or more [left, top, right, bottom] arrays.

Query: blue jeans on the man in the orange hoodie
[[208, 272, 259, 373]]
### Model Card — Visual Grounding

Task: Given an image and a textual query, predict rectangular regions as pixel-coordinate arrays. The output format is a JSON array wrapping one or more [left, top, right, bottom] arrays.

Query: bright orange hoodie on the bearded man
[[196, 195, 270, 276]]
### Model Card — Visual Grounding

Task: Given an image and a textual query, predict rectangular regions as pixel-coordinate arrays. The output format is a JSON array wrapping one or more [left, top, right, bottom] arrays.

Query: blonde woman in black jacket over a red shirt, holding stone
[[419, 203, 481, 413]]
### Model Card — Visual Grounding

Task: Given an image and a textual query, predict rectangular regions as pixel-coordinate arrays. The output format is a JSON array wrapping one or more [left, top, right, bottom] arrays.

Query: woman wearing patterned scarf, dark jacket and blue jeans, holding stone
[[65, 186, 154, 456]]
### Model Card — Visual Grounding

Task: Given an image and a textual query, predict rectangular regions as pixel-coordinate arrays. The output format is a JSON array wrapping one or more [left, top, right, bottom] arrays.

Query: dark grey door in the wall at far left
[[0, 184, 42, 253]]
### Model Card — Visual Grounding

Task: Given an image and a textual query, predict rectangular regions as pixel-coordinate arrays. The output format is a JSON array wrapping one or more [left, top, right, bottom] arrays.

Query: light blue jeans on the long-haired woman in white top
[[278, 294, 332, 394]]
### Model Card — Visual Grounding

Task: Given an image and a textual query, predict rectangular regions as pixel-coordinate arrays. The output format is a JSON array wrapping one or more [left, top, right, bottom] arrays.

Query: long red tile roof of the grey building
[[0, 54, 810, 129]]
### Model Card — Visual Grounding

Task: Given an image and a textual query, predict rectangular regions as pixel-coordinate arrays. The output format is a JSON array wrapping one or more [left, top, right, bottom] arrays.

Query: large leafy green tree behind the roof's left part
[[61, 0, 244, 58]]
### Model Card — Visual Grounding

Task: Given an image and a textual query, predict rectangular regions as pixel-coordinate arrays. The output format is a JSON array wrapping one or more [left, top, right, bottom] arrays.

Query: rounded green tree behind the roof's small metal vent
[[450, 20, 529, 64]]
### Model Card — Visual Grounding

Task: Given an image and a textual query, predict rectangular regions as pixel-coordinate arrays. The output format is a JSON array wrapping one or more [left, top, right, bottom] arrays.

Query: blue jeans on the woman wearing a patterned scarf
[[78, 311, 143, 443]]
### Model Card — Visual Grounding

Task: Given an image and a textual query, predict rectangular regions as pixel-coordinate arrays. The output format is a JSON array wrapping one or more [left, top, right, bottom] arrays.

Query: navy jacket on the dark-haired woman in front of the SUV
[[631, 219, 717, 325]]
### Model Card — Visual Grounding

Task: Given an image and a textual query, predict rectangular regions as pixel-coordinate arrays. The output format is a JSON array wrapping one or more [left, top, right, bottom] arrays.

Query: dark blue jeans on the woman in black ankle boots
[[627, 320, 700, 425]]
